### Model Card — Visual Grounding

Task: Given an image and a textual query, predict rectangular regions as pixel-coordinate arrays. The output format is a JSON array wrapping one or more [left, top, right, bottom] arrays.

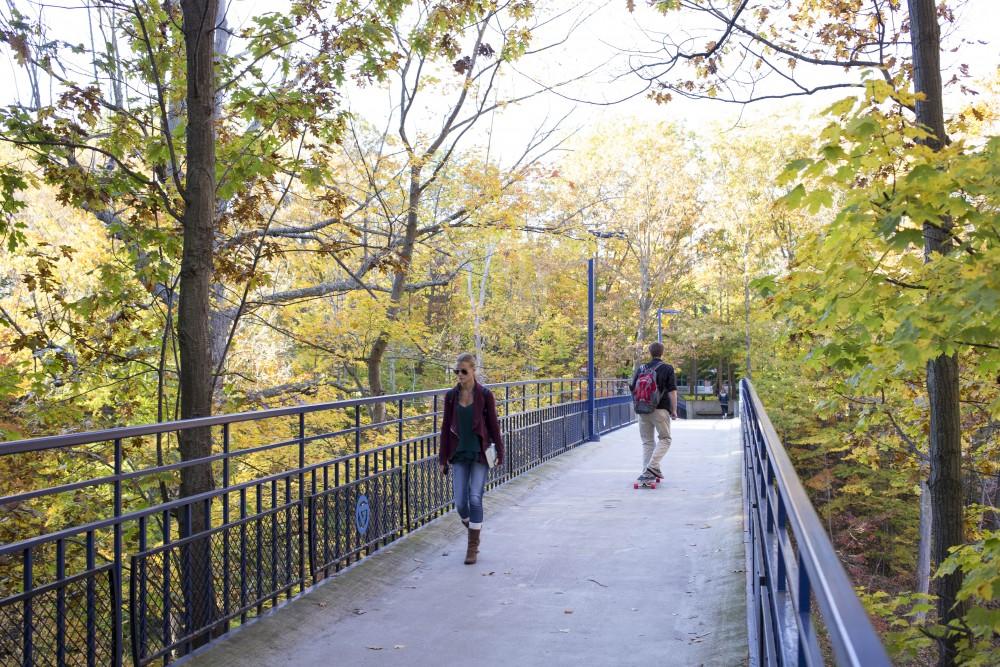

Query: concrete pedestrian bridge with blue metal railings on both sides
[[0, 380, 889, 667]]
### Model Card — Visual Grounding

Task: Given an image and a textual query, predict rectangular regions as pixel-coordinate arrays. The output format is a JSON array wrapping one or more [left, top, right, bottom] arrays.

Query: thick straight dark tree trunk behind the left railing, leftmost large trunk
[[177, 0, 218, 645]]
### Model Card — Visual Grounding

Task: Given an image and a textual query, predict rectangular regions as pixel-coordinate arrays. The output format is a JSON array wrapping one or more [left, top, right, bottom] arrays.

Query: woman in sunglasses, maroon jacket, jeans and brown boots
[[439, 353, 504, 565]]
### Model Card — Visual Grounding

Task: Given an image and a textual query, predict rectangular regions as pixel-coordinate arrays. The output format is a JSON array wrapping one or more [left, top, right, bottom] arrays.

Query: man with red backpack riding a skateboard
[[629, 342, 677, 483]]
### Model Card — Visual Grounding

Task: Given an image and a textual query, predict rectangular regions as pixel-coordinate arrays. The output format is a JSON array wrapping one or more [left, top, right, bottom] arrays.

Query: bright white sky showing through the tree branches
[[0, 0, 1000, 159]]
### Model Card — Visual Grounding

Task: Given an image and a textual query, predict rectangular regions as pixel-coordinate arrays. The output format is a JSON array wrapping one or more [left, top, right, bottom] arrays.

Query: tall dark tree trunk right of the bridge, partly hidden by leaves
[[909, 0, 965, 667]]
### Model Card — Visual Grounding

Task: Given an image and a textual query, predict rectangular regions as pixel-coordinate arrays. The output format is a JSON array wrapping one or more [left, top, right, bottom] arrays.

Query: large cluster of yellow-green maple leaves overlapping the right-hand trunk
[[779, 75, 1000, 410]]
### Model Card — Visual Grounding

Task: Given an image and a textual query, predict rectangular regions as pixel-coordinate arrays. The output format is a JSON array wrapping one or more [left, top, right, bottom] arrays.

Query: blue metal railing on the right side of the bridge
[[740, 379, 891, 667]]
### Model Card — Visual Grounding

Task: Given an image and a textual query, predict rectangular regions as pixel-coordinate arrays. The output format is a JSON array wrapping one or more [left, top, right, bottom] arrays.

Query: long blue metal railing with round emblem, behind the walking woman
[[0, 378, 635, 667]]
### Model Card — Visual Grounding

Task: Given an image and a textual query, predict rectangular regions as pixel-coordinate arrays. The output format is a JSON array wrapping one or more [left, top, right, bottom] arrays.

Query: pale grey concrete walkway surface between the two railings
[[187, 420, 747, 667]]
